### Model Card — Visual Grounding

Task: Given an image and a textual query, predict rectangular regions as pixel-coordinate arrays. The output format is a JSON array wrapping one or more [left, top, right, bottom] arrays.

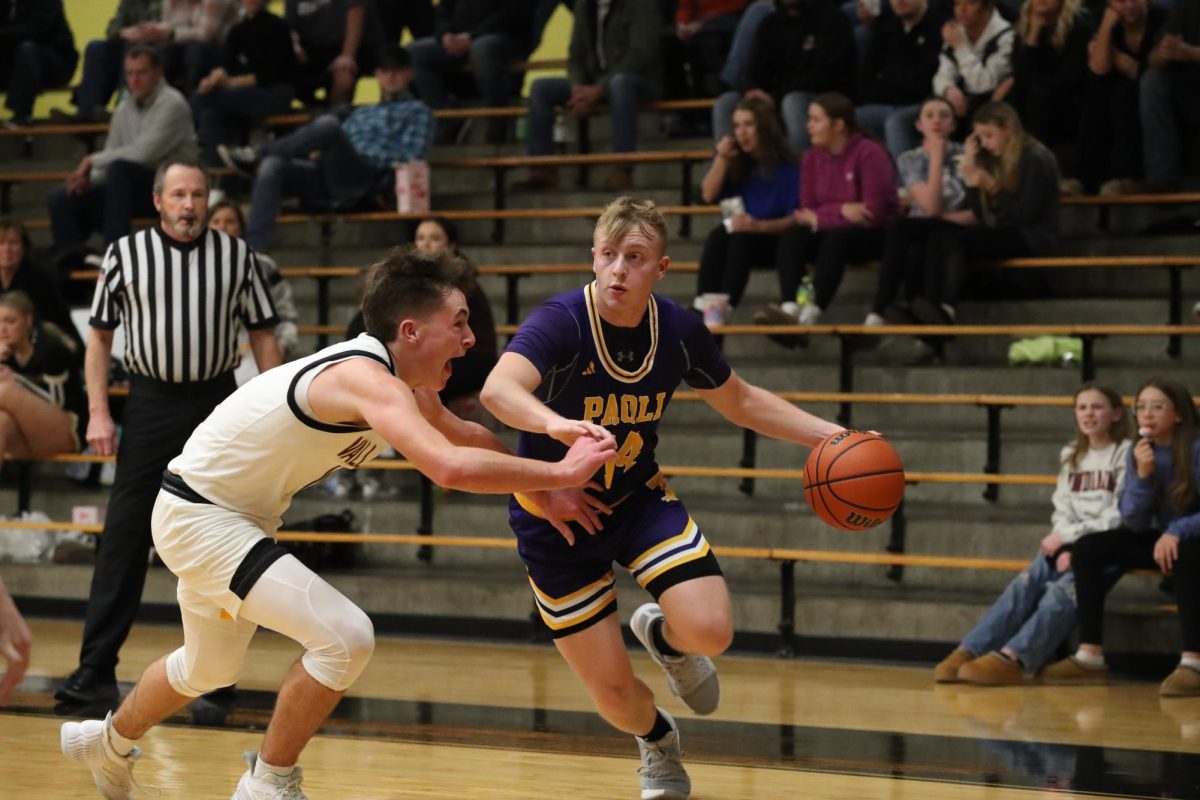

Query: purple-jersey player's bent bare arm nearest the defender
[[479, 353, 616, 446]]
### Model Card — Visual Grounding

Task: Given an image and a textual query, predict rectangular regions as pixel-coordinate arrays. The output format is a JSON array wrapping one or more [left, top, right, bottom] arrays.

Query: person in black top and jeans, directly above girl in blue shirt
[[713, 0, 857, 156]]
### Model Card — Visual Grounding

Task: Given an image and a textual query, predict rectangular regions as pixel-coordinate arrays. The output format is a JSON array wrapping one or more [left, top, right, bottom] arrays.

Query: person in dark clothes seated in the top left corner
[[0, 0, 79, 127]]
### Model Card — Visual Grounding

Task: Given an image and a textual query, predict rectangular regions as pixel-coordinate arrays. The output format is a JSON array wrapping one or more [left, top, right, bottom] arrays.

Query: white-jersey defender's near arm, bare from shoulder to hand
[[308, 359, 616, 494]]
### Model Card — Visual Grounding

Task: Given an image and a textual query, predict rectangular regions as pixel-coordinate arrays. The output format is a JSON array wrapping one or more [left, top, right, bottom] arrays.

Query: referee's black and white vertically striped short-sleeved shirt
[[89, 225, 278, 383]]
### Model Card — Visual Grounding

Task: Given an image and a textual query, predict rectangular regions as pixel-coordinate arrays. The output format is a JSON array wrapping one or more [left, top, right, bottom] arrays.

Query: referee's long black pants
[[79, 372, 236, 676]]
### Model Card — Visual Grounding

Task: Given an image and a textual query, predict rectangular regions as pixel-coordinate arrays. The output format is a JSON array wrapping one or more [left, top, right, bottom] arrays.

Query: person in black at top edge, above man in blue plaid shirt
[[283, 0, 381, 108]]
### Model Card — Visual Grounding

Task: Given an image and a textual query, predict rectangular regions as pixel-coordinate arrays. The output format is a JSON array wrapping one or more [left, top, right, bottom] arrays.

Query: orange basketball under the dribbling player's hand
[[804, 431, 904, 530]]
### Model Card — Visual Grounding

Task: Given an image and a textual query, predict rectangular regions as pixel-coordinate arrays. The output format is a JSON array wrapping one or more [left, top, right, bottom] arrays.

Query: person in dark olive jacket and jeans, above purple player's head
[[522, 0, 662, 192]]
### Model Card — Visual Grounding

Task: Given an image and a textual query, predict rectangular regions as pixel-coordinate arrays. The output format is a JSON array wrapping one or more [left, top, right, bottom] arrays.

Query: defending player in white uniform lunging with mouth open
[[61, 249, 616, 800]]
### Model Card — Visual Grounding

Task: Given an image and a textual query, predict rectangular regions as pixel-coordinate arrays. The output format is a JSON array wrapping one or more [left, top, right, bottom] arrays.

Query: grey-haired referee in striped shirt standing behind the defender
[[54, 161, 281, 703]]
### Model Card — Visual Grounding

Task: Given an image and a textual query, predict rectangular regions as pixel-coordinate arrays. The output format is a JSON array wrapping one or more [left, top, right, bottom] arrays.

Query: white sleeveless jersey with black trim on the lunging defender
[[167, 333, 396, 522]]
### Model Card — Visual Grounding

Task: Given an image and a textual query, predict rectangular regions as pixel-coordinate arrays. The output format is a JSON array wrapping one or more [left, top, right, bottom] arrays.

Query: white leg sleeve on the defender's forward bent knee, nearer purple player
[[241, 555, 374, 692]]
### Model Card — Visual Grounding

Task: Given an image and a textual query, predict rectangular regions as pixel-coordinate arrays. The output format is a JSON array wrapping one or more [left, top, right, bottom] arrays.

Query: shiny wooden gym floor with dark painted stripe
[[0, 620, 1200, 800]]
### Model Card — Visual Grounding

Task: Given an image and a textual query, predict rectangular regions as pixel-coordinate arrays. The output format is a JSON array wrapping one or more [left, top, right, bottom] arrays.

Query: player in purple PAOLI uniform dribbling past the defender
[[482, 197, 842, 800]]
